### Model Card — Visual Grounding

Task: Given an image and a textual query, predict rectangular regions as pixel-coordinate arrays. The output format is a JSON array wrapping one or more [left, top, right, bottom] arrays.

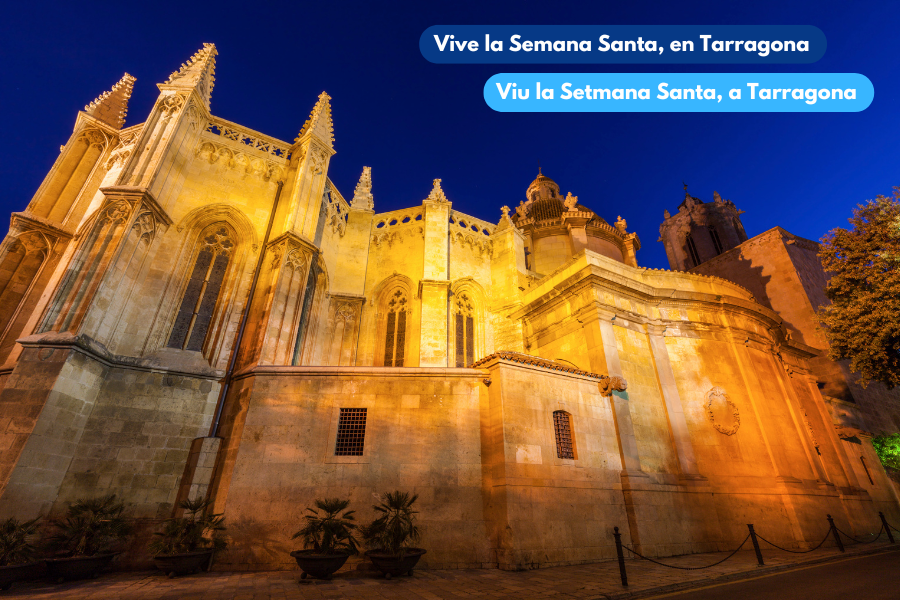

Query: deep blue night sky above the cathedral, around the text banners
[[0, 0, 900, 267]]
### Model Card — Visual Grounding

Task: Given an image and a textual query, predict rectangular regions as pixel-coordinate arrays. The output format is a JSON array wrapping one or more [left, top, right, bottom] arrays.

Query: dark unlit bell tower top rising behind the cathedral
[[658, 185, 747, 271]]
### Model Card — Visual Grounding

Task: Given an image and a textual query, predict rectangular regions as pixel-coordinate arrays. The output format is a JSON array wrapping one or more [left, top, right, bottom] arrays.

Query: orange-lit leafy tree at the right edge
[[819, 187, 900, 389]]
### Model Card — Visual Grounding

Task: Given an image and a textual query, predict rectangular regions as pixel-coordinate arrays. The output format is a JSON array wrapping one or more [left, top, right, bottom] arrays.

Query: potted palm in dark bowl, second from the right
[[291, 498, 359, 579]]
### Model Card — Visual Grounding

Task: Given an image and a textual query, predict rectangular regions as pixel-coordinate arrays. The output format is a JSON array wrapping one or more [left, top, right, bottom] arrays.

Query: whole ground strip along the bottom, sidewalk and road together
[[0, 541, 900, 600]]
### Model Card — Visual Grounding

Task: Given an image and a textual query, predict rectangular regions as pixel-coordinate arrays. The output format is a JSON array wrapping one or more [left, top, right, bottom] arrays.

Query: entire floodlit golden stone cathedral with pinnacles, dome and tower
[[0, 44, 900, 570]]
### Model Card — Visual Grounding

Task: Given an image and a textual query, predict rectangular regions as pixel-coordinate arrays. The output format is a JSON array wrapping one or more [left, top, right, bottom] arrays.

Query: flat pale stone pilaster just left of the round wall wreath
[[645, 323, 706, 480]]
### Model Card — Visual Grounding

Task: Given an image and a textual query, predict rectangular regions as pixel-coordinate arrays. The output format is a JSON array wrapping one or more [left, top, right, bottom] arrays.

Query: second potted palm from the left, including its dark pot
[[44, 494, 131, 582]]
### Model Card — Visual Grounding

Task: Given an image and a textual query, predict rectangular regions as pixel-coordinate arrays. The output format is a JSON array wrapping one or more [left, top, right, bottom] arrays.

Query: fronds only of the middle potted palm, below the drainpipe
[[149, 498, 228, 555]]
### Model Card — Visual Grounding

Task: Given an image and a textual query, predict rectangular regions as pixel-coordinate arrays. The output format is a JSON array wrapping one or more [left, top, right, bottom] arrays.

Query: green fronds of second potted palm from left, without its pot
[[48, 494, 131, 557]]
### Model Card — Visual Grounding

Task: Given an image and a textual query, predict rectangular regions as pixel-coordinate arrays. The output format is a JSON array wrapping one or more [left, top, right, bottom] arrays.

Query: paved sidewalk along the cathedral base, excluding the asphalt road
[[7, 542, 900, 600]]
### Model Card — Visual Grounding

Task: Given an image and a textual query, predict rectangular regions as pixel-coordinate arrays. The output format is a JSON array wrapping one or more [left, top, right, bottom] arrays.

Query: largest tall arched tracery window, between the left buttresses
[[166, 223, 235, 352]]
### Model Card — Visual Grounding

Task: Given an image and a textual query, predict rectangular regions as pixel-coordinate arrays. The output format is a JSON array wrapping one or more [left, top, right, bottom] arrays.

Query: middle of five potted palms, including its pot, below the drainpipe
[[149, 498, 228, 577]]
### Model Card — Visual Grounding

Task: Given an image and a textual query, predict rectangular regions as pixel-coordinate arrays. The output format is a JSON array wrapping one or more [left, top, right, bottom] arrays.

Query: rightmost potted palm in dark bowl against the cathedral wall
[[360, 490, 425, 579]]
